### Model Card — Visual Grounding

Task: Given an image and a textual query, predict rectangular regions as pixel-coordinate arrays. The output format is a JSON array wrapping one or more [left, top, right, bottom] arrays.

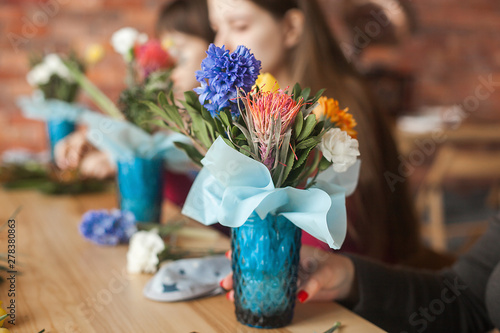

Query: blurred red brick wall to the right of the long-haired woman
[[356, 0, 500, 122]]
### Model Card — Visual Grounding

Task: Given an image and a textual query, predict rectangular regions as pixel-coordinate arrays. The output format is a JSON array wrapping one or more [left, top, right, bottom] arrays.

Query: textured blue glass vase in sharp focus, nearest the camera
[[231, 213, 302, 328]]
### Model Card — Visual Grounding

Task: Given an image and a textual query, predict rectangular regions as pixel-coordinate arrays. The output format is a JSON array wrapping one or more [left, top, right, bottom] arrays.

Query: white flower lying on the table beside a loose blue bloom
[[127, 229, 165, 273]]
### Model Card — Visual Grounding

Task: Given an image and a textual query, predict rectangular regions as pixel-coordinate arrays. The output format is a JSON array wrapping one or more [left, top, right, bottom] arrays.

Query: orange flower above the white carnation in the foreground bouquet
[[313, 96, 358, 139]]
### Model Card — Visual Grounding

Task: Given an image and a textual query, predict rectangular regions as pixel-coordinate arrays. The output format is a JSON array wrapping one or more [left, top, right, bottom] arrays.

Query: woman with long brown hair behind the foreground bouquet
[[208, 0, 450, 267]]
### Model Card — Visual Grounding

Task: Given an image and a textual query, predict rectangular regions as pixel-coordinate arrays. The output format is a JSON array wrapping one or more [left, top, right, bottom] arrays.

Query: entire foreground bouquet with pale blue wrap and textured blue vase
[[146, 44, 359, 328]]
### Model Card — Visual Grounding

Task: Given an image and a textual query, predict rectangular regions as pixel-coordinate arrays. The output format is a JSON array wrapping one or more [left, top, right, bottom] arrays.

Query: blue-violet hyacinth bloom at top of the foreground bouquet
[[194, 44, 261, 116]]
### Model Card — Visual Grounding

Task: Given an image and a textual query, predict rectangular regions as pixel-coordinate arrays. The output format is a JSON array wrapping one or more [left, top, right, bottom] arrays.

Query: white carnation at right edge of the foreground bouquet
[[320, 128, 359, 172]]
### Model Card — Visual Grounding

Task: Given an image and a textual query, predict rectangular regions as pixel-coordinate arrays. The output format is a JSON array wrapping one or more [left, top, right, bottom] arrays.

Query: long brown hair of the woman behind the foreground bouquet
[[251, 0, 420, 262]]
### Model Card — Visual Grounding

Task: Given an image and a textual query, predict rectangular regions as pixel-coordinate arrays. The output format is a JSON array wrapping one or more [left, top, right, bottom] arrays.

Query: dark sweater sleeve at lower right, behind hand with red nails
[[345, 214, 500, 333]]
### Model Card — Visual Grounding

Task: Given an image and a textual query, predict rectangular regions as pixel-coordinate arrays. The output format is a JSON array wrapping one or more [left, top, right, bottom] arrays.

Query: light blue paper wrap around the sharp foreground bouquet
[[182, 137, 362, 249]]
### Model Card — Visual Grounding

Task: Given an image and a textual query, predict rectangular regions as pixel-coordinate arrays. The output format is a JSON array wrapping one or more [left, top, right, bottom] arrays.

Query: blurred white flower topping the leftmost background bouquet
[[26, 53, 73, 87]]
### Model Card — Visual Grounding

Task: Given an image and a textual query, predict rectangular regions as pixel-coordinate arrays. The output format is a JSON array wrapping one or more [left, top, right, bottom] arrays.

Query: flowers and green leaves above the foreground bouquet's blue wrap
[[145, 44, 359, 188]]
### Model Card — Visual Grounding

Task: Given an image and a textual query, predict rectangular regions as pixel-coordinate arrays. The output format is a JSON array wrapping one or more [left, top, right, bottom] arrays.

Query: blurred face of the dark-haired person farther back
[[161, 31, 208, 98]]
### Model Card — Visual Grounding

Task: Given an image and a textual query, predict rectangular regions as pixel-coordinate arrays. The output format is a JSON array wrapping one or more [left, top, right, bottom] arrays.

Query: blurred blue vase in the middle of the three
[[117, 157, 163, 223]]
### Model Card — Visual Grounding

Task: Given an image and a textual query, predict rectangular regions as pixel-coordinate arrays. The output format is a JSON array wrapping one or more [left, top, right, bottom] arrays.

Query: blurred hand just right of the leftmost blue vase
[[54, 131, 92, 170]]
